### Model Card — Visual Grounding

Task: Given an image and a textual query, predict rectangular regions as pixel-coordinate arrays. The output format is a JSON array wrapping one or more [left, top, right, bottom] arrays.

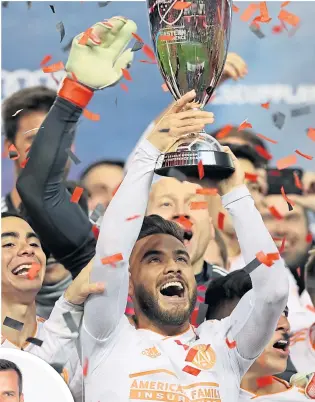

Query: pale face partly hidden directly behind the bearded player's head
[[146, 177, 214, 265]]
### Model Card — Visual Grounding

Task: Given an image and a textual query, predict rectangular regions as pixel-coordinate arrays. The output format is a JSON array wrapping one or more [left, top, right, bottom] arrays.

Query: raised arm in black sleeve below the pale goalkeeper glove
[[17, 96, 96, 277]]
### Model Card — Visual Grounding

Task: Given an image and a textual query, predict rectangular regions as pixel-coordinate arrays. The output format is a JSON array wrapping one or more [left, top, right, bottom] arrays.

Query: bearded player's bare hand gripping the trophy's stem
[[146, 91, 214, 152]]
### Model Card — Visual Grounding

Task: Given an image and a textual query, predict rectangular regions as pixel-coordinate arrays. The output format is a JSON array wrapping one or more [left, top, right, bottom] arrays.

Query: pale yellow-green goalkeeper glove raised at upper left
[[66, 17, 137, 90]]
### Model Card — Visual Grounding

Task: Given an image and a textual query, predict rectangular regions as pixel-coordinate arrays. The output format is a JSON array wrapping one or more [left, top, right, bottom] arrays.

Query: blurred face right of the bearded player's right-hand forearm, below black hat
[[260, 194, 310, 269]]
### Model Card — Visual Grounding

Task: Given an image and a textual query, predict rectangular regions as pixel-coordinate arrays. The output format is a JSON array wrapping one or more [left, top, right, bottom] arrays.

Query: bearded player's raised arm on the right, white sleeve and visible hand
[[217, 150, 289, 371]]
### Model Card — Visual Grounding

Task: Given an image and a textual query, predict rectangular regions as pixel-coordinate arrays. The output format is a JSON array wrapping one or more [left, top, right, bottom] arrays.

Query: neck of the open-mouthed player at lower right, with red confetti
[[241, 370, 287, 396]]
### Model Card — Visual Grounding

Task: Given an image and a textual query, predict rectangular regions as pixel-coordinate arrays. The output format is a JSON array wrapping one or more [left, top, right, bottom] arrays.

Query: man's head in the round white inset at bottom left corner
[[0, 359, 24, 402]]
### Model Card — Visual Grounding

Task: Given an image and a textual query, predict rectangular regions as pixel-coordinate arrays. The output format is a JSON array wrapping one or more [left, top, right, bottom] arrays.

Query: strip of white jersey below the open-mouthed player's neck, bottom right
[[238, 377, 309, 402]]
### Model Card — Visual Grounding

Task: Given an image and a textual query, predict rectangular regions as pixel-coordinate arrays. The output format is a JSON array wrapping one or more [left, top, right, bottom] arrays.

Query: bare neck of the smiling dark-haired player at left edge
[[1, 298, 37, 348]]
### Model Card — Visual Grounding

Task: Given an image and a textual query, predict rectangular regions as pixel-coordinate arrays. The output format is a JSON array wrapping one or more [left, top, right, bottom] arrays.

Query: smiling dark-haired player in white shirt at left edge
[[1, 213, 104, 402]]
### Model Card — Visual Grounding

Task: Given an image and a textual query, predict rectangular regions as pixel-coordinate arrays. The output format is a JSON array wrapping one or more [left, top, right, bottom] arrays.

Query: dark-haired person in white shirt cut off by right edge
[[290, 249, 315, 374]]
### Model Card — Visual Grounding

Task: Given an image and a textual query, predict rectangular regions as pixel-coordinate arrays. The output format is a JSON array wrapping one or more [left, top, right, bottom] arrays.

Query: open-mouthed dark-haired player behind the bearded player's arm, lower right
[[206, 270, 315, 402]]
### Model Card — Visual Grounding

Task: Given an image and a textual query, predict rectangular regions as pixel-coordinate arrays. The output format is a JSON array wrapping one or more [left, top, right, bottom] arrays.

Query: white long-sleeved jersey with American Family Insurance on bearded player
[[81, 140, 288, 402]]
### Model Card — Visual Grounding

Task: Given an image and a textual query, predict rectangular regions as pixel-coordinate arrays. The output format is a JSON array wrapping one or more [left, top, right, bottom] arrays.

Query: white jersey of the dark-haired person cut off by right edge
[[290, 322, 315, 373]]
